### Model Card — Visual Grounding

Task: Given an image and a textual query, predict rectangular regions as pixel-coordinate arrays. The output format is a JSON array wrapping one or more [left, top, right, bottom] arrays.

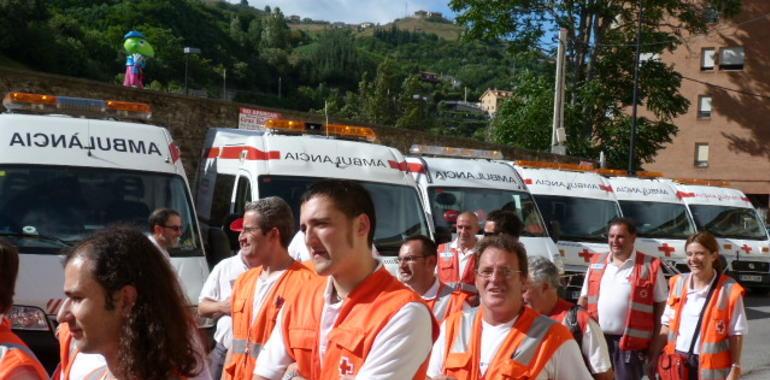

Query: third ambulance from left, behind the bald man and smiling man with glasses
[[407, 145, 564, 272]]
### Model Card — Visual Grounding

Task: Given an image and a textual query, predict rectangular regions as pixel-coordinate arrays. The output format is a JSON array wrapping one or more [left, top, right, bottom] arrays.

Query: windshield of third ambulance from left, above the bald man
[[428, 187, 547, 236]]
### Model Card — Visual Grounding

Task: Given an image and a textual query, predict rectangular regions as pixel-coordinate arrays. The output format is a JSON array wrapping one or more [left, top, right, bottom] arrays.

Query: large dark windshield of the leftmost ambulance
[[0, 165, 203, 256]]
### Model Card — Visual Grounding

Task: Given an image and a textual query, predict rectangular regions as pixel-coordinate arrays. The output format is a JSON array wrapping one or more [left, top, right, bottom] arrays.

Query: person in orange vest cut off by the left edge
[[0, 239, 48, 380]]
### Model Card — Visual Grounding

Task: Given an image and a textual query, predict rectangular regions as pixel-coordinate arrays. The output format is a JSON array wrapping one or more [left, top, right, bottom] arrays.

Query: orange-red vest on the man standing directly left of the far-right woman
[[586, 251, 661, 351]]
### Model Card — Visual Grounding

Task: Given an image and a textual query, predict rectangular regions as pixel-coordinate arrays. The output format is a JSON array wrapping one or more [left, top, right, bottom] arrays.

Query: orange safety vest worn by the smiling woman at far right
[[664, 274, 744, 379]]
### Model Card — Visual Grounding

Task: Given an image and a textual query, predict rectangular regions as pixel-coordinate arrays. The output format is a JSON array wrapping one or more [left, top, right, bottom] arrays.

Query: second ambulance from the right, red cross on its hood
[[608, 173, 695, 275]]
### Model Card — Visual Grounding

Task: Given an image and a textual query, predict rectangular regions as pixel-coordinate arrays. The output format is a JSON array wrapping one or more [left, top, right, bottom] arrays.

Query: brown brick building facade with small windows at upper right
[[645, 0, 770, 217]]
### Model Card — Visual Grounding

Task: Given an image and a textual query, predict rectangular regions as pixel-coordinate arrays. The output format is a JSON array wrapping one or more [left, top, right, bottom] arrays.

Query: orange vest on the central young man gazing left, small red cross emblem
[[281, 267, 439, 380]]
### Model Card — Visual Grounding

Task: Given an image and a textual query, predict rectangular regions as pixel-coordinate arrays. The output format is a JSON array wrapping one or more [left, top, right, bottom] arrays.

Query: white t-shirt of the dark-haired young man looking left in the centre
[[254, 267, 433, 379]]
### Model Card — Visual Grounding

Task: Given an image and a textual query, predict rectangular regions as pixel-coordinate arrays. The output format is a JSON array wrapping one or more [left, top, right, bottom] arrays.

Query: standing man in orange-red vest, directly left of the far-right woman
[[578, 218, 668, 380]]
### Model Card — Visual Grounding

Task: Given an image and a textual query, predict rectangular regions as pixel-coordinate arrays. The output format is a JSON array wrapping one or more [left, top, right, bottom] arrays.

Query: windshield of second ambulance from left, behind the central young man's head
[[259, 176, 430, 256]]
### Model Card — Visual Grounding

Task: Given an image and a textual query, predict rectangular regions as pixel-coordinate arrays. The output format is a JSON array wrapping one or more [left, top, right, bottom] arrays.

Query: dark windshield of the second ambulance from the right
[[619, 201, 695, 239]]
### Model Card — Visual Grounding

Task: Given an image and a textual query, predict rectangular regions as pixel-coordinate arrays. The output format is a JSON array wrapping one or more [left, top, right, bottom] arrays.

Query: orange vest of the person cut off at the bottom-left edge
[[0, 318, 48, 379]]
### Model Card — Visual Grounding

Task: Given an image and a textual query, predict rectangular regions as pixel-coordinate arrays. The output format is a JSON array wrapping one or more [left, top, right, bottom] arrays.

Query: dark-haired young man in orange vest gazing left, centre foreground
[[254, 180, 438, 380]]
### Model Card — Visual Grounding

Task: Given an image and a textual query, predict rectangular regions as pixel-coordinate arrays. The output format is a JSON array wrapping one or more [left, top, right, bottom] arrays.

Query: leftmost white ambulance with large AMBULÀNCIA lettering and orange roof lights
[[0, 92, 212, 363]]
